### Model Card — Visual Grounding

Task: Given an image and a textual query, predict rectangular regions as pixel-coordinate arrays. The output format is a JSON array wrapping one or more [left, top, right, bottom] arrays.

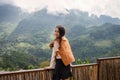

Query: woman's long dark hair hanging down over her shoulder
[[56, 25, 66, 48]]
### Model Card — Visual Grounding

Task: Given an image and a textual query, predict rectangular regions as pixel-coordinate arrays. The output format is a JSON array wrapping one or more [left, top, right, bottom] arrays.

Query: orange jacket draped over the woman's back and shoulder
[[58, 37, 75, 66]]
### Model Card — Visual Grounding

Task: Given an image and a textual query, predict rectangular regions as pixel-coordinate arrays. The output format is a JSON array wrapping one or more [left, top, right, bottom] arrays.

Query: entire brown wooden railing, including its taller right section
[[0, 57, 120, 80]]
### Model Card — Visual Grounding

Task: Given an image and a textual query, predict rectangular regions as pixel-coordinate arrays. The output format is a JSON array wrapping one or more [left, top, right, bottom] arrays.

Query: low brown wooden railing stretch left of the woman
[[0, 69, 52, 80]]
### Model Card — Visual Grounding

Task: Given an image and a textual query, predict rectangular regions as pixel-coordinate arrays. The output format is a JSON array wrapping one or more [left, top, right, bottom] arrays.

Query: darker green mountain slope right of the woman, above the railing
[[70, 23, 120, 61]]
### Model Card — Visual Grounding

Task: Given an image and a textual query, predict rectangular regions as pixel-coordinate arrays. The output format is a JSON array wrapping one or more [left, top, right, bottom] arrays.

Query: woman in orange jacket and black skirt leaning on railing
[[47, 25, 75, 80]]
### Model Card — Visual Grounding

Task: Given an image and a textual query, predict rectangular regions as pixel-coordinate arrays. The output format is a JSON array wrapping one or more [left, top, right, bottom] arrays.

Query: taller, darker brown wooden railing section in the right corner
[[97, 56, 120, 80]]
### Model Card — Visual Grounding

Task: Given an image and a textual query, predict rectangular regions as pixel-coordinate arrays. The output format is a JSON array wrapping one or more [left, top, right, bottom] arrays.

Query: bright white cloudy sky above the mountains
[[0, 0, 120, 18]]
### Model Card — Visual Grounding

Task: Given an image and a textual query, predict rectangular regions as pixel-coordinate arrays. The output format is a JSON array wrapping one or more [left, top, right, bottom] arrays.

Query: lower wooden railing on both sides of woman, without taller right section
[[0, 63, 97, 80]]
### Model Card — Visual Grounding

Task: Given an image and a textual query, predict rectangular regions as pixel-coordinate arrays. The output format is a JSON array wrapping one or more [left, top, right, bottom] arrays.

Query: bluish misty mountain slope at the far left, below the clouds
[[0, 4, 29, 39]]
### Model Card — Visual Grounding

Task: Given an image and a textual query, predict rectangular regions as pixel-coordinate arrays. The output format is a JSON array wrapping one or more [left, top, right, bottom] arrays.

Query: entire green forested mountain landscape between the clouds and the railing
[[0, 5, 120, 71]]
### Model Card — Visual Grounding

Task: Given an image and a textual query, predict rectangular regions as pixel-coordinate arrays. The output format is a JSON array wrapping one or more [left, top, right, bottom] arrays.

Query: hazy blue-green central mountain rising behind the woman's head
[[8, 8, 120, 45]]
